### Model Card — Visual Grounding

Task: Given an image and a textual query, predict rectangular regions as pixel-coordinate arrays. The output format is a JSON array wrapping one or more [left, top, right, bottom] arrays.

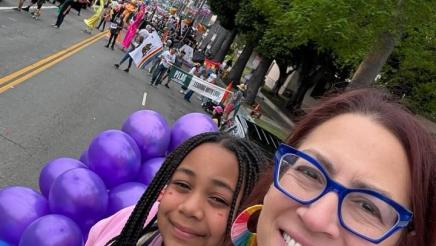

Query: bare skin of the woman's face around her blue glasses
[[257, 114, 411, 246]]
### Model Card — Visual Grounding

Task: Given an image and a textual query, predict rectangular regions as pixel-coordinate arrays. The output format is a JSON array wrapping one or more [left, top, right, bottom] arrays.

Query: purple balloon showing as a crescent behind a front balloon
[[39, 157, 86, 198]]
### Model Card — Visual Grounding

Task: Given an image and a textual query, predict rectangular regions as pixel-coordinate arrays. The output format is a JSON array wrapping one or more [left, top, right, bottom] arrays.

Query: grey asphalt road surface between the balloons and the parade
[[0, 0, 203, 188]]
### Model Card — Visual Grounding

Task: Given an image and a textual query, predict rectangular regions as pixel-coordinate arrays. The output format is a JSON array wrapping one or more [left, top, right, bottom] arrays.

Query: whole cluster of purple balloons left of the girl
[[0, 110, 218, 246]]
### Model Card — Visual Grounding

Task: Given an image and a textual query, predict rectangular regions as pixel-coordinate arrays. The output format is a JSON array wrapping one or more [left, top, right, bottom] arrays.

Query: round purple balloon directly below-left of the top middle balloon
[[88, 130, 141, 189]]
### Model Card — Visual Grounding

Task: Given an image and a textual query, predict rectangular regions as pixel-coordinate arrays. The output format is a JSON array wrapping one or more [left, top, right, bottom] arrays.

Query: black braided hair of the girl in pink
[[106, 132, 267, 246]]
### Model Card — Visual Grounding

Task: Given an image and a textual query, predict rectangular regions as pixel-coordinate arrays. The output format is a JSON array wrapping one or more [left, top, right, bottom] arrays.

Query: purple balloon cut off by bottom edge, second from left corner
[[19, 214, 83, 246]]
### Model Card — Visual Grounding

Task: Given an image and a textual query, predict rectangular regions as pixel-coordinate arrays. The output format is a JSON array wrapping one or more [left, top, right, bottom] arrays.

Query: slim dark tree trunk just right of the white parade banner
[[246, 58, 272, 105]]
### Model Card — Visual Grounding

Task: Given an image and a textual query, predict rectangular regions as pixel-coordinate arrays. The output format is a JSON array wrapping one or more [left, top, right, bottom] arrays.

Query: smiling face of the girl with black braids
[[157, 143, 238, 246]]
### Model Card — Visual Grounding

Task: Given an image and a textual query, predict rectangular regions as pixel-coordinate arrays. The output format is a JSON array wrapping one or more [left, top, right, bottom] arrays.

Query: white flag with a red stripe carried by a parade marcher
[[129, 31, 163, 68]]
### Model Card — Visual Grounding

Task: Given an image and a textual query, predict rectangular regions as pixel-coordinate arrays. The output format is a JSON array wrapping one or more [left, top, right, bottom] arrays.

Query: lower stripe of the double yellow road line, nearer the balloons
[[0, 31, 108, 94]]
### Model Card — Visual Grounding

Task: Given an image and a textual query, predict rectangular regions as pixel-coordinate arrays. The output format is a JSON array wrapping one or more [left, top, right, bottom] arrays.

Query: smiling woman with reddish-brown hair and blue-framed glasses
[[232, 90, 436, 246]]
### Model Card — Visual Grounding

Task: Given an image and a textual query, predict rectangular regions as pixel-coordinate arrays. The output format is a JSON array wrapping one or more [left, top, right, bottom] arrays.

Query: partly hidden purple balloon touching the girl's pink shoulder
[[108, 182, 147, 215]]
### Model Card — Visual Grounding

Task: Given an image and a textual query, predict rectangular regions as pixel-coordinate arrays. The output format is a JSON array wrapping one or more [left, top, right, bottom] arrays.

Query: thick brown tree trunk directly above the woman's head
[[351, 32, 395, 88]]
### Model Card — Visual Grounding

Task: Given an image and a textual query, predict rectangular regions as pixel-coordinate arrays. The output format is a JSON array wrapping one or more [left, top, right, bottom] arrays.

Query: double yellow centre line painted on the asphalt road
[[0, 31, 107, 93]]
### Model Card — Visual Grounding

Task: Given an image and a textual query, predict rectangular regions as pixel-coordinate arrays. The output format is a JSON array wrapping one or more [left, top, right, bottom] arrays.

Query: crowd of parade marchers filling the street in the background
[[12, 0, 247, 125]]
